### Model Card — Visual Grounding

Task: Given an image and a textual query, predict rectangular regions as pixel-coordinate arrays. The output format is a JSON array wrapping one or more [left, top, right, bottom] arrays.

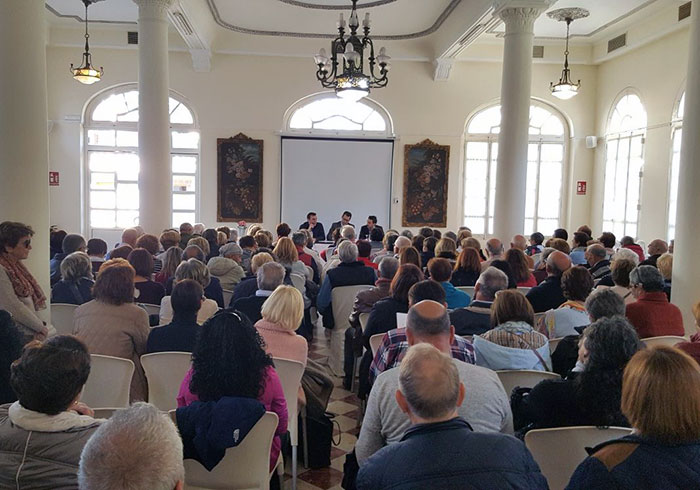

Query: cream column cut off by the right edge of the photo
[[671, 0, 700, 334]]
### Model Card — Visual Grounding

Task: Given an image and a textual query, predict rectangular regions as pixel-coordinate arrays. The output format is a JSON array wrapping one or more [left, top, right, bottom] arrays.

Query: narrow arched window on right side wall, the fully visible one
[[603, 91, 647, 237]]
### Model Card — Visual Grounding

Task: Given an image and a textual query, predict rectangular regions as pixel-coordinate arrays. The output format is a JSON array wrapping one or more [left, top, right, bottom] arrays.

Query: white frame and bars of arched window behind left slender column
[[80, 83, 202, 236]]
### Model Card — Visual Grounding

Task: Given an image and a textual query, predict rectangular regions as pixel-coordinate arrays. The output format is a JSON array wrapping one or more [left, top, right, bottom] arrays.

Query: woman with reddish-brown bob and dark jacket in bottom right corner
[[567, 347, 700, 490]]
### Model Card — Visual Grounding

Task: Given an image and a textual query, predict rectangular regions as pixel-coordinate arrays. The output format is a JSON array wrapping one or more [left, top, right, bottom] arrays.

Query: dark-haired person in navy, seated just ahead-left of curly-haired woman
[[146, 279, 205, 354]]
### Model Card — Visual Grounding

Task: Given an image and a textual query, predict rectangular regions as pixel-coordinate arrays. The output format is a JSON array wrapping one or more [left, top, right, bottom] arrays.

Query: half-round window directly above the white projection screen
[[285, 92, 393, 136]]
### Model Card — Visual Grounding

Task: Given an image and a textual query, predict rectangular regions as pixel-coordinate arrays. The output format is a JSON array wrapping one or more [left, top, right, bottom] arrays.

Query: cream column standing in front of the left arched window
[[134, 0, 172, 235]]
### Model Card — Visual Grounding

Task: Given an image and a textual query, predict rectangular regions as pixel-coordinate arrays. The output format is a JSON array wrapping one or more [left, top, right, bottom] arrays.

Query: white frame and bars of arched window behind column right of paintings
[[460, 97, 573, 237]]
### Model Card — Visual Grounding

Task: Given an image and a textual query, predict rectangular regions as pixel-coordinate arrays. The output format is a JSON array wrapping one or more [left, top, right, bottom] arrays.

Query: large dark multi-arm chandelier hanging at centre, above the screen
[[314, 0, 391, 101]]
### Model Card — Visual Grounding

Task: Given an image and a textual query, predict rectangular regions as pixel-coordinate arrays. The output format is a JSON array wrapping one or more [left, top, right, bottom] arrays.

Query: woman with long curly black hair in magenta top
[[177, 310, 288, 468]]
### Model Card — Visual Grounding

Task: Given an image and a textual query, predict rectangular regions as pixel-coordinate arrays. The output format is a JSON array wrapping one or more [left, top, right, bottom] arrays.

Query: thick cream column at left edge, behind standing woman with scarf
[[0, 0, 50, 297]]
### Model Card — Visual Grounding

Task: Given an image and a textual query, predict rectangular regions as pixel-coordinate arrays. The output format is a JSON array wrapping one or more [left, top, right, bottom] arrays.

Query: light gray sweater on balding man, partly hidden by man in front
[[355, 359, 513, 465]]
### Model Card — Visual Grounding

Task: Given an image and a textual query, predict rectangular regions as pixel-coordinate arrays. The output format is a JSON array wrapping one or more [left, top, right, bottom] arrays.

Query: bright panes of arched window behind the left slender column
[[83, 84, 199, 230]]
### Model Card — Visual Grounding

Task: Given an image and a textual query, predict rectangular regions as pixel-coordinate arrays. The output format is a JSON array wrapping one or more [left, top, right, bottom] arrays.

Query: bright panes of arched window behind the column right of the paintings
[[464, 101, 568, 235]]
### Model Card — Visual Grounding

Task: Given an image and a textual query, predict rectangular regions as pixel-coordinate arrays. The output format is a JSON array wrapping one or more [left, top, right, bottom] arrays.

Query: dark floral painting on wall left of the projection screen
[[216, 133, 263, 223]]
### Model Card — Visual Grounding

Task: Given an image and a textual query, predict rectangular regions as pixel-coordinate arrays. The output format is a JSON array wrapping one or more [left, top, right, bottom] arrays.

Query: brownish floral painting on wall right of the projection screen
[[402, 140, 450, 228]]
